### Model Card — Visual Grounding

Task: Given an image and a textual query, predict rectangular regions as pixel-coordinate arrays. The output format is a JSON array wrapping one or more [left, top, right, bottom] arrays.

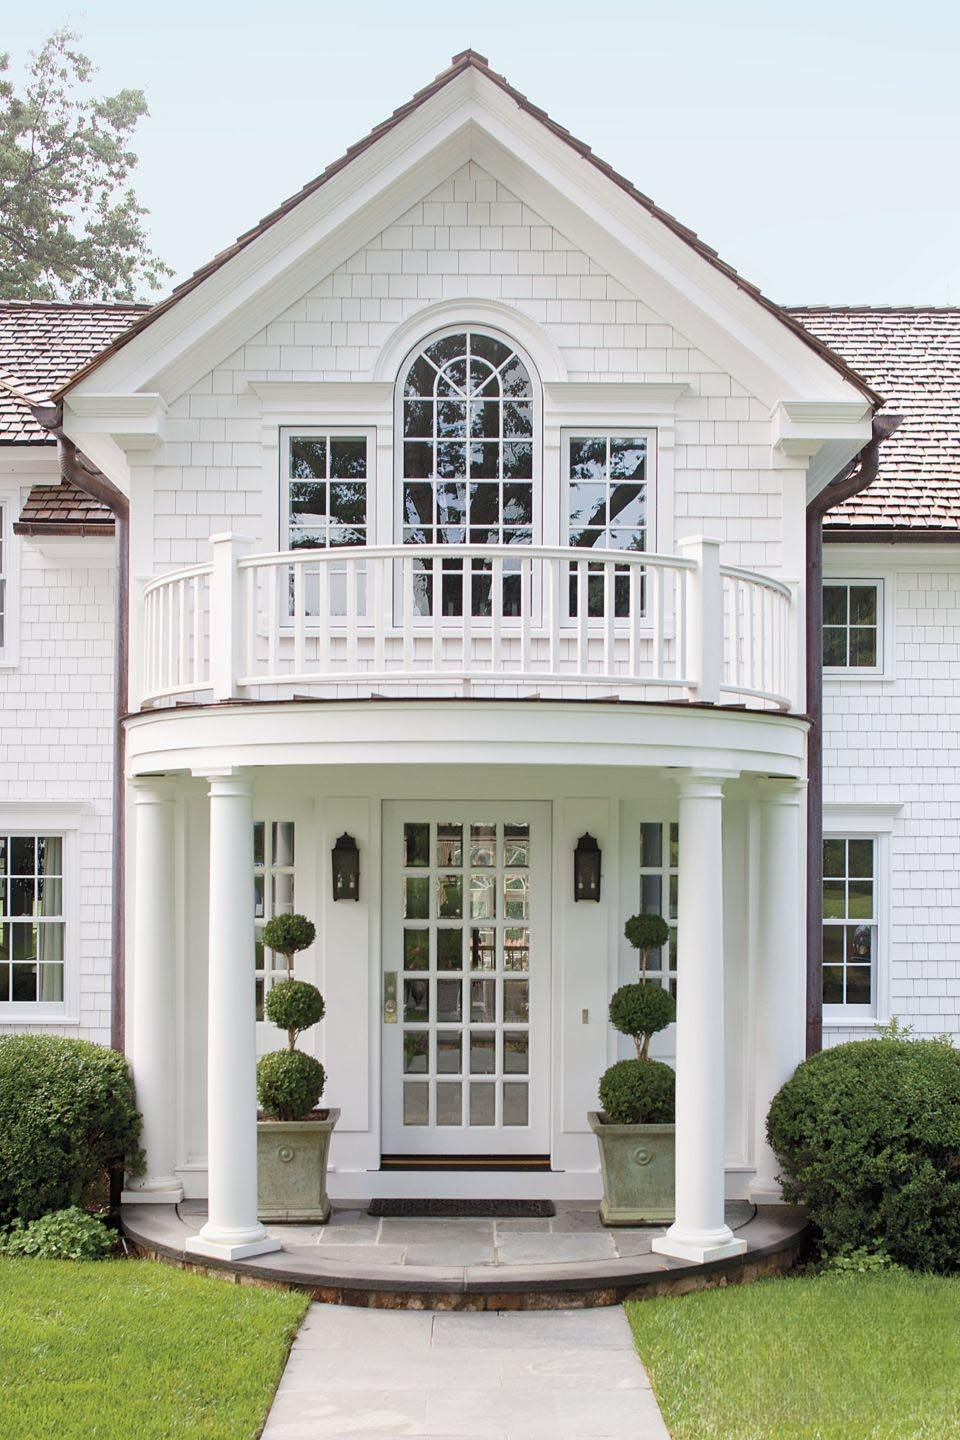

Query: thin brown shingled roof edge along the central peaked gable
[[55, 50, 879, 405]]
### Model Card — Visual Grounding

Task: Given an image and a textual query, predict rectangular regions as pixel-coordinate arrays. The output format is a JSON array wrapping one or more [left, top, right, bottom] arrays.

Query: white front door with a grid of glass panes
[[380, 802, 550, 1156]]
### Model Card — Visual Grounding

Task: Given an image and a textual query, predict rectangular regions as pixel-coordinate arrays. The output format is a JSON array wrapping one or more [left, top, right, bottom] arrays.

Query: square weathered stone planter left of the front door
[[256, 1110, 340, 1224]]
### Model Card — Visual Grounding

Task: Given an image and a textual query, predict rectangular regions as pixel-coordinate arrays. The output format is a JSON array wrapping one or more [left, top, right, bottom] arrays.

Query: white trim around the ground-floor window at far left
[[0, 802, 89, 1030]]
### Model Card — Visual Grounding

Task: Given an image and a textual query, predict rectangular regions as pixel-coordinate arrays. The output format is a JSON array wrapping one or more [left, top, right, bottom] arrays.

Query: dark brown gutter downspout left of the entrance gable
[[30, 403, 130, 1054]]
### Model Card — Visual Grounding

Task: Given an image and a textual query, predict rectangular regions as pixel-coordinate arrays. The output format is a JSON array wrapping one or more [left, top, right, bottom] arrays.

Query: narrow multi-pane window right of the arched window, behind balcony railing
[[567, 433, 648, 616]]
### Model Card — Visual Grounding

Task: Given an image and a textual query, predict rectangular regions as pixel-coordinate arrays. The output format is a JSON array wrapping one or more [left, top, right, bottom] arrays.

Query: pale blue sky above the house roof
[[7, 0, 960, 304]]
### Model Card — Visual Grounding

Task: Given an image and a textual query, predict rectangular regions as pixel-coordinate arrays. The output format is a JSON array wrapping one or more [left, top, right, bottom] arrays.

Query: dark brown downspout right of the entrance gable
[[806, 415, 900, 1056]]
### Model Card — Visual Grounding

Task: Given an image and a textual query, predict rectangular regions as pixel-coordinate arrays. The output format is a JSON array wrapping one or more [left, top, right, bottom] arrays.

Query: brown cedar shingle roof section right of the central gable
[[792, 305, 960, 540]]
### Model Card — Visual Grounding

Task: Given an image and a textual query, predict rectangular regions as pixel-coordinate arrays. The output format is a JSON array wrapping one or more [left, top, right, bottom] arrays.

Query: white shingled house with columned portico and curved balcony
[[0, 52, 960, 1260]]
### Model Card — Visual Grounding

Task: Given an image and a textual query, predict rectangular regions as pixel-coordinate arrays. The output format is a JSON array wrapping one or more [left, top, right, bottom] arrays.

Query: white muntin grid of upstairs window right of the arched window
[[564, 428, 652, 619]]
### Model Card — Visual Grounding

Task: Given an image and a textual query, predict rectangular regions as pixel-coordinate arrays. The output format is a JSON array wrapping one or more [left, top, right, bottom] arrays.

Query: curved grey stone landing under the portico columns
[[122, 1201, 806, 1310]]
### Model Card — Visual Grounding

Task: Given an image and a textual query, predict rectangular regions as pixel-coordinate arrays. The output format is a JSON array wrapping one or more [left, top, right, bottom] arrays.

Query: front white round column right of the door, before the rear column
[[653, 770, 747, 1264]]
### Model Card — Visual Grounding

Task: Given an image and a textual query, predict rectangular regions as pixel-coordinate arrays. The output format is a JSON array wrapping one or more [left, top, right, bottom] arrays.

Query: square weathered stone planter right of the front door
[[587, 1110, 675, 1225]]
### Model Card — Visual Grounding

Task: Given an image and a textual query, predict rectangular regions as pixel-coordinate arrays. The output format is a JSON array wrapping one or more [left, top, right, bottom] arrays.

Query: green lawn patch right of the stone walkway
[[626, 1272, 960, 1440]]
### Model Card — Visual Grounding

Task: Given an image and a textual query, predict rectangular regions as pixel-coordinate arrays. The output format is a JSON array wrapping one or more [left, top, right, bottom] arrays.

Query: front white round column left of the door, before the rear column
[[186, 772, 281, 1260]]
